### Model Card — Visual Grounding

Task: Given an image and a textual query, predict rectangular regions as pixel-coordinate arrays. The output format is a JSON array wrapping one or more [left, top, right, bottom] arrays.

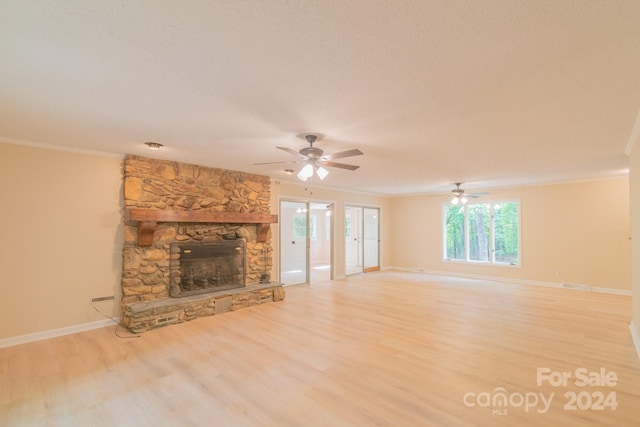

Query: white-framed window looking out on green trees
[[443, 201, 520, 265]]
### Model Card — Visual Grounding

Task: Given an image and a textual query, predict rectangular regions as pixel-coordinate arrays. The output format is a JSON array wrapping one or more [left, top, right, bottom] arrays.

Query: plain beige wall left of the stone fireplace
[[0, 143, 122, 339]]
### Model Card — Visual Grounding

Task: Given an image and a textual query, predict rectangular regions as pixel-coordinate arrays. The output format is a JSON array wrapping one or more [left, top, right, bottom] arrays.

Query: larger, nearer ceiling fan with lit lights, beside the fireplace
[[254, 134, 364, 181]]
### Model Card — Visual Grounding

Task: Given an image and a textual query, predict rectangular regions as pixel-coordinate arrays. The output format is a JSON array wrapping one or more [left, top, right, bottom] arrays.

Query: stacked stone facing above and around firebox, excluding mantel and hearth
[[122, 155, 272, 312]]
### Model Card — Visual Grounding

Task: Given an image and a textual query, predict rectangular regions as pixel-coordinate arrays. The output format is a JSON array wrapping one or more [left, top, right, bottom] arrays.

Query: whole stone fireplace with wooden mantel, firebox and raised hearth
[[122, 155, 284, 332]]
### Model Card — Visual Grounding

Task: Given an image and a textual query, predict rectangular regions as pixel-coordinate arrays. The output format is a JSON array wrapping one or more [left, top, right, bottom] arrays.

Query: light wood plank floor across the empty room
[[0, 271, 640, 427]]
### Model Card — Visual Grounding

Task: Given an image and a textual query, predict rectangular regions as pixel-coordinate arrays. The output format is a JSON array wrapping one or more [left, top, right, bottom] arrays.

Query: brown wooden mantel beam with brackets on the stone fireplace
[[125, 208, 278, 246]]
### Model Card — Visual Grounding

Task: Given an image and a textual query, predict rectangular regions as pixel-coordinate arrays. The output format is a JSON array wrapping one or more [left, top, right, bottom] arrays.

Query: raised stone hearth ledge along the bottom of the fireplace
[[122, 282, 284, 333]]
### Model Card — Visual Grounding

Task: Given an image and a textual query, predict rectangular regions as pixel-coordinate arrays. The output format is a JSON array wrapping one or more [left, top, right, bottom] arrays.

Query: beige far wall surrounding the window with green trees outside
[[389, 177, 631, 290]]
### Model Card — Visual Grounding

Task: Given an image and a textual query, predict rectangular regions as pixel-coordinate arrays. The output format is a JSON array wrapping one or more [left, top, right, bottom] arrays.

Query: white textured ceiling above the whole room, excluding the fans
[[0, 0, 640, 194]]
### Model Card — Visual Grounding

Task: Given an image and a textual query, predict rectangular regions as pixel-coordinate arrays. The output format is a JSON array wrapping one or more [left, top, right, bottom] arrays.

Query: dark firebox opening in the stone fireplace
[[170, 240, 246, 297]]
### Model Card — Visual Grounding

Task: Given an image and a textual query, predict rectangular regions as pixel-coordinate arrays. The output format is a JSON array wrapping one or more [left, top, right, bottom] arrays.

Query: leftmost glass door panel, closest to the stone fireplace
[[279, 200, 309, 285]]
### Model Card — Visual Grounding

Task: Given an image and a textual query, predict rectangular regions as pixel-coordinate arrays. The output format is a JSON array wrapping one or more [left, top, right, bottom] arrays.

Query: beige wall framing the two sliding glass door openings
[[271, 180, 391, 278]]
